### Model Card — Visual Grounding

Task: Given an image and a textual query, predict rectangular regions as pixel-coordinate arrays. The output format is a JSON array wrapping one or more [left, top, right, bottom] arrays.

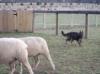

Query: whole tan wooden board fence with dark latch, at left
[[0, 10, 33, 32]]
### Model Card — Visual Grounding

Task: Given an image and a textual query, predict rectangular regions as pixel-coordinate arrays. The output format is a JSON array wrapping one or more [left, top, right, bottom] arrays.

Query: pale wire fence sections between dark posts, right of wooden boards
[[33, 13, 100, 38]]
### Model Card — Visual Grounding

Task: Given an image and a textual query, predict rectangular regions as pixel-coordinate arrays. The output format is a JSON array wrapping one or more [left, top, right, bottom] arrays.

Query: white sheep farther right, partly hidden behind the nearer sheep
[[20, 37, 55, 70]]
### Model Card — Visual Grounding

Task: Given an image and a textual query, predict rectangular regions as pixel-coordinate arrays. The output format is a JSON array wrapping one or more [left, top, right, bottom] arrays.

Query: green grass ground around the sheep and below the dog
[[0, 28, 100, 74]]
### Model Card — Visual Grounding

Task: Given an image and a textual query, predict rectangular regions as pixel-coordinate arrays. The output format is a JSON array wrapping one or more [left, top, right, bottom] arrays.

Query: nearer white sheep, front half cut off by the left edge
[[0, 38, 34, 74]]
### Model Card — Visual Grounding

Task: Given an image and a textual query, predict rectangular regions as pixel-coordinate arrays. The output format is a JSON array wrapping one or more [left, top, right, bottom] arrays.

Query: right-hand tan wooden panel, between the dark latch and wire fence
[[17, 10, 33, 32]]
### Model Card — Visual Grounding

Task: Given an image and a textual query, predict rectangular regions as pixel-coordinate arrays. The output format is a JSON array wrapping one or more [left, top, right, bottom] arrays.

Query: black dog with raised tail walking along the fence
[[61, 31, 83, 46]]
